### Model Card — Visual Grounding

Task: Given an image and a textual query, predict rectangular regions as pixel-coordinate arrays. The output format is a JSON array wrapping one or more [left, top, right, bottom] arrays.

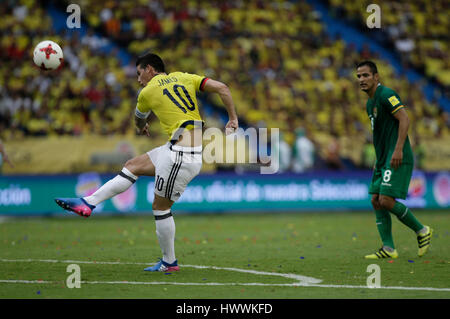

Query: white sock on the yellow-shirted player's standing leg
[[153, 209, 176, 264]]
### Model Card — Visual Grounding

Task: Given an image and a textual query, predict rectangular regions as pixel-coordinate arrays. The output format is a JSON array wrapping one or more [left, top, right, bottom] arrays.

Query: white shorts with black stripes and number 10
[[147, 143, 202, 202]]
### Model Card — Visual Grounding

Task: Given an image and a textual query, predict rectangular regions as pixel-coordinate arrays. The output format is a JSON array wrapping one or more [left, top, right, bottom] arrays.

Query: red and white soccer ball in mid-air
[[33, 40, 63, 70]]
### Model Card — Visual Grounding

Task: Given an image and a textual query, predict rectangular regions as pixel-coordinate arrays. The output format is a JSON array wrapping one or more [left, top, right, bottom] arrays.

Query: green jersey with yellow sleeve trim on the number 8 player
[[366, 84, 414, 169]]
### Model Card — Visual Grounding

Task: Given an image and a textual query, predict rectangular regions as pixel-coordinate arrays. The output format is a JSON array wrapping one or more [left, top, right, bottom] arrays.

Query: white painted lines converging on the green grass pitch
[[0, 259, 450, 292]]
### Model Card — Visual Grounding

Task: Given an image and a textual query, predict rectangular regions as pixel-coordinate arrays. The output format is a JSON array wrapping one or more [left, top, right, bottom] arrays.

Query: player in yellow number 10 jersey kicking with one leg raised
[[55, 53, 239, 271]]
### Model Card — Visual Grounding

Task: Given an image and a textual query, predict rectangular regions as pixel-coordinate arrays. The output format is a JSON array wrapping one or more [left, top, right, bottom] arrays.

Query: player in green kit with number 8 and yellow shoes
[[356, 61, 433, 259]]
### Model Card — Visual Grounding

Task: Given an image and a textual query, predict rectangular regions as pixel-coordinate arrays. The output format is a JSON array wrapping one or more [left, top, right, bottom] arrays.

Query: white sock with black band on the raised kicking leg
[[83, 167, 138, 206]]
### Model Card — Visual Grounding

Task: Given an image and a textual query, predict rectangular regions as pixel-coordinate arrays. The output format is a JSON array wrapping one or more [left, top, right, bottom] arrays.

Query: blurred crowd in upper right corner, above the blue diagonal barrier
[[327, 0, 450, 90]]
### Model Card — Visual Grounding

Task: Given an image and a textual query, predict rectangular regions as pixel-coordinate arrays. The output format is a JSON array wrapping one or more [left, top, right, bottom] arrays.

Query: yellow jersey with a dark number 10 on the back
[[136, 72, 208, 142]]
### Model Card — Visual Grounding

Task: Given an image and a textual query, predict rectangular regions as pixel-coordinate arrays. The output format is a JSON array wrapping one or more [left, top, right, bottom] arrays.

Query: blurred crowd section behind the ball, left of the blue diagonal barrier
[[0, 1, 142, 140]]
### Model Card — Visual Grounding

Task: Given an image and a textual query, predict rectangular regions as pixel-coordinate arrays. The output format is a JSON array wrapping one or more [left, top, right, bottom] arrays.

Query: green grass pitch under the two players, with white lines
[[0, 210, 450, 299]]
